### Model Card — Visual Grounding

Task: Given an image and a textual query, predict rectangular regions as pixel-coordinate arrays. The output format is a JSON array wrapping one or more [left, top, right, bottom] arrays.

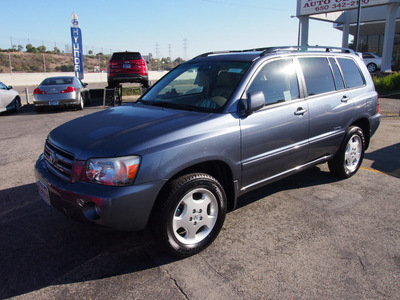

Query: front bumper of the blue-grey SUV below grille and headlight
[[35, 155, 164, 231]]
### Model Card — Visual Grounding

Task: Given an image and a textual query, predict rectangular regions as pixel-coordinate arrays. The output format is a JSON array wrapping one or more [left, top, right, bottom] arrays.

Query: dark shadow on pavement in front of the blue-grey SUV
[[0, 183, 172, 299]]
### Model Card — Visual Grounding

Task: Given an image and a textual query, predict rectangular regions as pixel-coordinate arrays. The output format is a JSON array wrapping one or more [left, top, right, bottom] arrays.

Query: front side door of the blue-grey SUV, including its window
[[240, 58, 309, 190]]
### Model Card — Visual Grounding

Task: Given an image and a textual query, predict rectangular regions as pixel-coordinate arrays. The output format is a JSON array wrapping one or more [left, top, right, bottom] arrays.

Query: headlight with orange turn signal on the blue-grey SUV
[[81, 156, 140, 186]]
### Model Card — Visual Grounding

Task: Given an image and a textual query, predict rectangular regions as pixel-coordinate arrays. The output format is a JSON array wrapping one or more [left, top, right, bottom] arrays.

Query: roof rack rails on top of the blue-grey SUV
[[194, 46, 355, 59]]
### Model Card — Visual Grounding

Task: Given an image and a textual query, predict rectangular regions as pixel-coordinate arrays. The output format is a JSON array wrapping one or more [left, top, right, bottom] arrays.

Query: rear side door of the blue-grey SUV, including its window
[[298, 56, 354, 161]]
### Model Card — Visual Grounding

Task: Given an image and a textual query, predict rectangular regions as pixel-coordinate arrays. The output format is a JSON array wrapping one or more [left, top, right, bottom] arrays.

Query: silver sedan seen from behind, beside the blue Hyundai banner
[[33, 76, 91, 112]]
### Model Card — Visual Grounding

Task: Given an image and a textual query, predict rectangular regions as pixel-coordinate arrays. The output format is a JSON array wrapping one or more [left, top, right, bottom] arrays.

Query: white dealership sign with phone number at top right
[[297, 0, 390, 16]]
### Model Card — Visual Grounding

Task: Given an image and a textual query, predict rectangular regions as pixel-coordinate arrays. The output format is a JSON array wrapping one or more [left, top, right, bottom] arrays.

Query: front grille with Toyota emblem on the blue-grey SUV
[[43, 141, 75, 181]]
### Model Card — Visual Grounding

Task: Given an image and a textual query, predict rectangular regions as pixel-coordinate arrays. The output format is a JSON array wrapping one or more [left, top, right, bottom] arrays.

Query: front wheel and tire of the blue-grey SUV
[[151, 173, 226, 257]]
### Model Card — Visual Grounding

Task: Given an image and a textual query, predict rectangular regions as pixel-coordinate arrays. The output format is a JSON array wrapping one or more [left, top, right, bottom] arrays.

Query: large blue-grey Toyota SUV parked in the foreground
[[35, 47, 380, 257]]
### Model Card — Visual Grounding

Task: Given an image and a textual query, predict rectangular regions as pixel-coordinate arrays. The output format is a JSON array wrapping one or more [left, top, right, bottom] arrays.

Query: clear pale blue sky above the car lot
[[0, 0, 342, 59]]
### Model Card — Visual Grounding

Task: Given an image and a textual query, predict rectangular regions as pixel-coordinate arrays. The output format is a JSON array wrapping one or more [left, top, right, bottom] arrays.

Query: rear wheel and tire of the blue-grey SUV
[[328, 126, 365, 178]]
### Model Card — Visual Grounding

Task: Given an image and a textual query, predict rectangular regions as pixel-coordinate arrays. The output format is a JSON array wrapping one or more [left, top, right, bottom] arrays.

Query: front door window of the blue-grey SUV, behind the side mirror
[[247, 59, 300, 105]]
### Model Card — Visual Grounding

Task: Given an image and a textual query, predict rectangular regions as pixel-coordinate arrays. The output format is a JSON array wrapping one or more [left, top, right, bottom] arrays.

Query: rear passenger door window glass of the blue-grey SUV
[[299, 57, 336, 96]]
